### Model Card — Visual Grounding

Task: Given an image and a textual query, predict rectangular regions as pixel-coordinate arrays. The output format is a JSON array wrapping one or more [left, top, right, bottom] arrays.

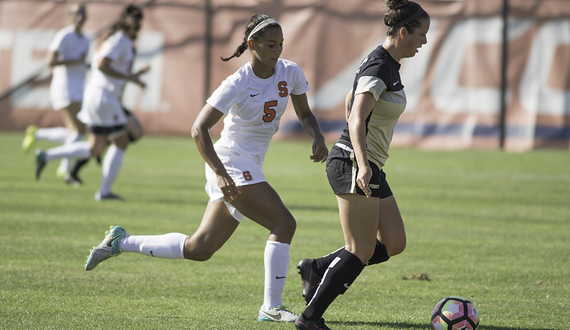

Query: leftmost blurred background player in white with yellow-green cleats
[[22, 3, 89, 176]]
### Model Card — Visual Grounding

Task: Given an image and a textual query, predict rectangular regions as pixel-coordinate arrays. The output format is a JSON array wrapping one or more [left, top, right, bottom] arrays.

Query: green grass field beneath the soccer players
[[0, 133, 570, 330]]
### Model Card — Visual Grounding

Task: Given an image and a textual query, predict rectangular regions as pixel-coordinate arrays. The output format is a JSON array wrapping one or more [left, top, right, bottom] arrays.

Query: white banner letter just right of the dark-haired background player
[[123, 31, 170, 112]]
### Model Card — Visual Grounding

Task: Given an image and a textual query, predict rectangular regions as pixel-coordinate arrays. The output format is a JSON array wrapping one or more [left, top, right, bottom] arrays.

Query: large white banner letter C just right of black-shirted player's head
[[430, 18, 532, 114]]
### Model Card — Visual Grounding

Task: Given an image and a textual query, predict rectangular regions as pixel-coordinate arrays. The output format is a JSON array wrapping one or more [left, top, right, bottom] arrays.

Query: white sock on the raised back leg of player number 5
[[121, 233, 188, 259]]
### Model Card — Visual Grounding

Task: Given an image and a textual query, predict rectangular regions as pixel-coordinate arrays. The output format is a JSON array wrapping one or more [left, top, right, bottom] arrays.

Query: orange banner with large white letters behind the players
[[0, 0, 570, 151]]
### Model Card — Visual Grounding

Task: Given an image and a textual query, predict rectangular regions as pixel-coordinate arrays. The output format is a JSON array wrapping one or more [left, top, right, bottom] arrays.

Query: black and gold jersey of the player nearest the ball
[[338, 46, 406, 167]]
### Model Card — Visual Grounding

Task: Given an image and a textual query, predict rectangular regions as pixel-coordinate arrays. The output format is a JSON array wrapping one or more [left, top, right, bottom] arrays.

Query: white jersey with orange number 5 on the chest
[[206, 59, 311, 156]]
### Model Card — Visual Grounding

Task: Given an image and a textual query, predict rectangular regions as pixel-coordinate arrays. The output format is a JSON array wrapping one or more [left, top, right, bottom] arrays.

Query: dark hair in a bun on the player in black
[[384, 0, 429, 38]]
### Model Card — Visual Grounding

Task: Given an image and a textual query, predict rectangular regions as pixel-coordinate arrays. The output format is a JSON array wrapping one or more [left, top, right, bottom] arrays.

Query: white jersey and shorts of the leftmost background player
[[48, 25, 89, 110]]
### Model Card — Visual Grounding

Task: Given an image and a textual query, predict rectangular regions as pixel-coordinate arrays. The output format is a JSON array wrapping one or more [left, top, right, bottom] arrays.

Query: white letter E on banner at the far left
[[10, 30, 56, 109]]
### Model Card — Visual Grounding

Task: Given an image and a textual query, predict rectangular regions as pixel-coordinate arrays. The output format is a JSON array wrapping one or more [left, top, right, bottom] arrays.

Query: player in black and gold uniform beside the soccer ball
[[295, 0, 430, 330]]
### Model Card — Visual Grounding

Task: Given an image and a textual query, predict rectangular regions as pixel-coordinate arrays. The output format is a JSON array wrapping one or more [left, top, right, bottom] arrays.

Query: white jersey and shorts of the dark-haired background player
[[77, 31, 134, 127]]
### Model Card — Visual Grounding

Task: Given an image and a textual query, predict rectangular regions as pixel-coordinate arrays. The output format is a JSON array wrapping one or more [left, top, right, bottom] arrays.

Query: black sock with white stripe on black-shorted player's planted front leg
[[303, 250, 364, 320]]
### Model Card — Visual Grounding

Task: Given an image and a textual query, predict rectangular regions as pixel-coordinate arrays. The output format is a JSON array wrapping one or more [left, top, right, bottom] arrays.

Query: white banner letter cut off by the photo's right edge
[[520, 20, 570, 116]]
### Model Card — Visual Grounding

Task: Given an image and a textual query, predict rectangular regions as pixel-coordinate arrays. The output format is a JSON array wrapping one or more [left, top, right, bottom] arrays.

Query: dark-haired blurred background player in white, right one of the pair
[[36, 5, 148, 201]]
